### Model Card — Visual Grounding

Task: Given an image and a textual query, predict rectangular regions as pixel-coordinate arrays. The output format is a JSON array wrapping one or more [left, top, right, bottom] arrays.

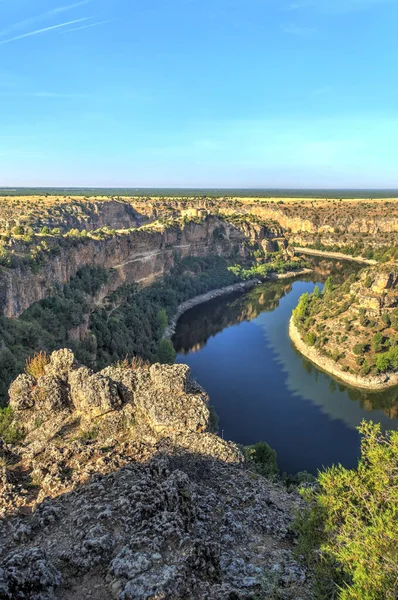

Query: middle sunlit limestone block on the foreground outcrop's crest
[[69, 367, 122, 415]]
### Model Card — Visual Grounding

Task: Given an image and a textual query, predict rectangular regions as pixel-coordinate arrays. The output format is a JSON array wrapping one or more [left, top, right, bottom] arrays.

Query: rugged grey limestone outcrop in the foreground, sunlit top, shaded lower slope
[[0, 350, 311, 600]]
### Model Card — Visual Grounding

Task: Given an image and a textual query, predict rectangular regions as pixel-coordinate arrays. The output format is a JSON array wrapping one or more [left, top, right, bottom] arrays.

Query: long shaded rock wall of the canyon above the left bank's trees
[[0, 217, 276, 318]]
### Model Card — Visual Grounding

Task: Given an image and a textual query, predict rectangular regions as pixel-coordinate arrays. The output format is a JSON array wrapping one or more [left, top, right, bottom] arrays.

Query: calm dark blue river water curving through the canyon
[[173, 266, 398, 473]]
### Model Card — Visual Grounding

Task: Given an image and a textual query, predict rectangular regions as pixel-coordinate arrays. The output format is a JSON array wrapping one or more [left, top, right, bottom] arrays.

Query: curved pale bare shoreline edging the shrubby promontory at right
[[289, 317, 398, 392]]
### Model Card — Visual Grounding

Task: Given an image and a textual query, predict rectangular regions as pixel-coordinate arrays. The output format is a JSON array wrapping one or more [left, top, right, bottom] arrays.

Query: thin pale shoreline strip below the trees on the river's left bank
[[163, 269, 312, 339]]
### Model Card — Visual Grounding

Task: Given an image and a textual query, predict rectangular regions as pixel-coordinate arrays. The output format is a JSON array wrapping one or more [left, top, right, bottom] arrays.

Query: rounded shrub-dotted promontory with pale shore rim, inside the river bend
[[290, 263, 398, 390]]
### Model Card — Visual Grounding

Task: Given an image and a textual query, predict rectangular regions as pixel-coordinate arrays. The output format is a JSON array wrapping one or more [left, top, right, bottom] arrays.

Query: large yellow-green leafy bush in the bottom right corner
[[295, 422, 398, 600]]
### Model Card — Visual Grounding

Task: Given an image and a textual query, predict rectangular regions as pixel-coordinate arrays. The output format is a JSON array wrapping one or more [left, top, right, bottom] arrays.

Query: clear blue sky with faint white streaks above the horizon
[[0, 0, 398, 188]]
